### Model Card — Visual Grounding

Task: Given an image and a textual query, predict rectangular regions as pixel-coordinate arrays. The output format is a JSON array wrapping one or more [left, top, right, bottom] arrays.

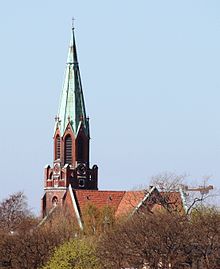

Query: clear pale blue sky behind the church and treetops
[[0, 0, 220, 212]]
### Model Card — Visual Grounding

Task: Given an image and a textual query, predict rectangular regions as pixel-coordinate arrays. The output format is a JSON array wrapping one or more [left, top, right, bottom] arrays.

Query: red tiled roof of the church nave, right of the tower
[[64, 187, 183, 221]]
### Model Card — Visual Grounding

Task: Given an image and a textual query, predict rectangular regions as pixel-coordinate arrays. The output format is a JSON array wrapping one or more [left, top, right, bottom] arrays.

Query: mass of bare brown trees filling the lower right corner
[[97, 208, 220, 269]]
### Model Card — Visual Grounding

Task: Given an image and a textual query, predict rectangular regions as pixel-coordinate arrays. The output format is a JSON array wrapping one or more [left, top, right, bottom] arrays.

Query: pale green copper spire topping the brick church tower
[[55, 27, 89, 136]]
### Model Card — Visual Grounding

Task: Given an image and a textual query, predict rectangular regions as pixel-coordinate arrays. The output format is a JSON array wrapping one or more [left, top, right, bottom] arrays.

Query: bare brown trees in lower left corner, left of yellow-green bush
[[0, 197, 78, 269]]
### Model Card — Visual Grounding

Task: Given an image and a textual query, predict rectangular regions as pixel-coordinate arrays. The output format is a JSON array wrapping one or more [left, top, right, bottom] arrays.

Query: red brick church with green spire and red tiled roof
[[41, 24, 182, 228]]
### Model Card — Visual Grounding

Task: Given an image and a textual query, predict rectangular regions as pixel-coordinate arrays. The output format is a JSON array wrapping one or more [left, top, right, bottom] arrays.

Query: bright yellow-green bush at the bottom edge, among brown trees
[[43, 239, 100, 269]]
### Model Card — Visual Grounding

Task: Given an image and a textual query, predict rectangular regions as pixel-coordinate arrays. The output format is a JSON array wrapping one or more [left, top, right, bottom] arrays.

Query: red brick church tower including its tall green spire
[[42, 27, 98, 216]]
